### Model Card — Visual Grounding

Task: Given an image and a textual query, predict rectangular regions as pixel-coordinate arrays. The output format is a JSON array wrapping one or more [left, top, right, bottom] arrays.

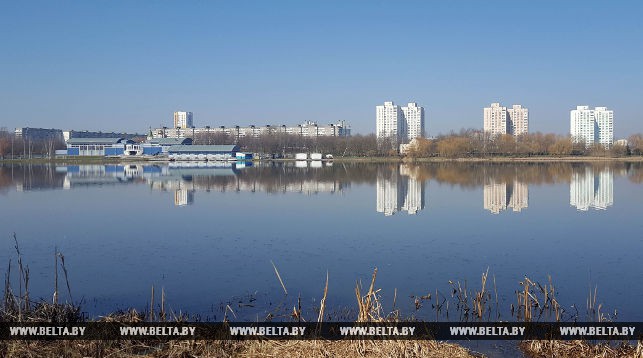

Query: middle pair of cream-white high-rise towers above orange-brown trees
[[483, 102, 529, 136]]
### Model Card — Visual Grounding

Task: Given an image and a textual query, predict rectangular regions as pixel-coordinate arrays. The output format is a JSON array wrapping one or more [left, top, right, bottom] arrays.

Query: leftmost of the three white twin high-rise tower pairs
[[375, 102, 424, 144]]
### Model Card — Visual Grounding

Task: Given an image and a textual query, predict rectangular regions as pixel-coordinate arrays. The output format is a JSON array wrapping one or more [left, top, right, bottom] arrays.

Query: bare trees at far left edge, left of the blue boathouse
[[0, 130, 66, 159]]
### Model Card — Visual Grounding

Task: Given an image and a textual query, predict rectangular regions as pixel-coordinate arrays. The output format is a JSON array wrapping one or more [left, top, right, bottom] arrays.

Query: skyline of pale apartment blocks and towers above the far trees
[[8, 101, 638, 141]]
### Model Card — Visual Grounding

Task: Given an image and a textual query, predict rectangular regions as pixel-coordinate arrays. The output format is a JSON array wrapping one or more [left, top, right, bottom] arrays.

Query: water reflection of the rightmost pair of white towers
[[569, 167, 614, 211]]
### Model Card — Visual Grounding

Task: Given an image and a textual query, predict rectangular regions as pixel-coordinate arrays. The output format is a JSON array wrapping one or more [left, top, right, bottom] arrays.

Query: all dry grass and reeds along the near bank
[[0, 252, 643, 358]]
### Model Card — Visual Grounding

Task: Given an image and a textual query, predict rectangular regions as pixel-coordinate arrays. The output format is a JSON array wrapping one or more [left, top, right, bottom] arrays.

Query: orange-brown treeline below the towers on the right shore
[[408, 130, 643, 158]]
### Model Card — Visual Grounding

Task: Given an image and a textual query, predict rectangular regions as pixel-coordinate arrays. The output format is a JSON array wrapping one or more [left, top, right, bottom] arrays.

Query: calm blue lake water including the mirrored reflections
[[0, 162, 643, 321]]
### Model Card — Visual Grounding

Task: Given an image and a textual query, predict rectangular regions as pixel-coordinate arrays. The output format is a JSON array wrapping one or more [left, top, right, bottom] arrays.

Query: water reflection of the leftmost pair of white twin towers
[[376, 164, 424, 216]]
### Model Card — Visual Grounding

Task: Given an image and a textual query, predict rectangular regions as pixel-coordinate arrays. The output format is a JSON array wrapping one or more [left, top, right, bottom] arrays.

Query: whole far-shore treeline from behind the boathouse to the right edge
[[194, 129, 643, 158]]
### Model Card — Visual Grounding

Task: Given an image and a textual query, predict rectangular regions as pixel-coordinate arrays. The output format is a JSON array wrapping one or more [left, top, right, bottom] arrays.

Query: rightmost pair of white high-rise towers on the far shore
[[569, 106, 614, 148]]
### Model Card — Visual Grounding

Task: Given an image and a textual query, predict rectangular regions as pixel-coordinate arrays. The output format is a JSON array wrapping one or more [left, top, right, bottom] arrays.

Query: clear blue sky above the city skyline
[[0, 0, 643, 138]]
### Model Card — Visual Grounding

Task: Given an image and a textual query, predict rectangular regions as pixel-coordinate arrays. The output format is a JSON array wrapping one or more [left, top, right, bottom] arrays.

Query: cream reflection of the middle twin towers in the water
[[483, 175, 529, 214]]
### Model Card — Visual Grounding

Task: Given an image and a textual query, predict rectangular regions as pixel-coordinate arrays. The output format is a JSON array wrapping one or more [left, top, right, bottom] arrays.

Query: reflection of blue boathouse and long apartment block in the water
[[47, 162, 350, 206]]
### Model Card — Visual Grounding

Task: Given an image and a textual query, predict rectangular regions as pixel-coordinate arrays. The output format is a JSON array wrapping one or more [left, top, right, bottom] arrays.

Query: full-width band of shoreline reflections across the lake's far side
[[0, 161, 643, 211]]
